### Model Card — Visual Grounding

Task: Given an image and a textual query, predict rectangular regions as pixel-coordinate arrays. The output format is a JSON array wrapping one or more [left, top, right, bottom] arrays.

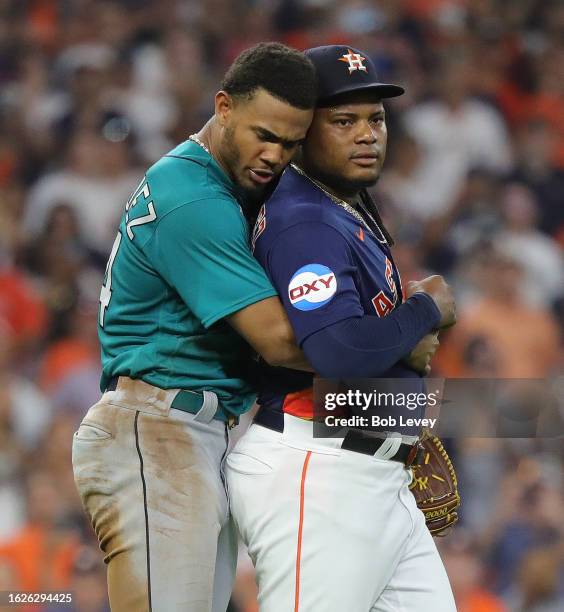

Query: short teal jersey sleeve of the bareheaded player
[[145, 198, 276, 328]]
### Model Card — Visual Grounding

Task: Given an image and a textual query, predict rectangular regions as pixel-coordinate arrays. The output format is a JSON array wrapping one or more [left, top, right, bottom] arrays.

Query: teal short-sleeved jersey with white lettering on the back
[[98, 141, 276, 414]]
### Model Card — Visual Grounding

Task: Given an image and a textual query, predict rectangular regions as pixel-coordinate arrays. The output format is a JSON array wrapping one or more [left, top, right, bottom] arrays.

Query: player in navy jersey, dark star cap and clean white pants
[[227, 46, 455, 612]]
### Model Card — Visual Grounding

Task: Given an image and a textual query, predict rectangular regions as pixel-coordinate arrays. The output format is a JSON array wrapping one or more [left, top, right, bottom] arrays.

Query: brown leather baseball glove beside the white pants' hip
[[409, 435, 460, 536]]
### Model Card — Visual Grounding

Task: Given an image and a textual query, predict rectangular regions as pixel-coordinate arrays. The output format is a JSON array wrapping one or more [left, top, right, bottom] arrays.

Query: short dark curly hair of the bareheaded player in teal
[[221, 42, 317, 109]]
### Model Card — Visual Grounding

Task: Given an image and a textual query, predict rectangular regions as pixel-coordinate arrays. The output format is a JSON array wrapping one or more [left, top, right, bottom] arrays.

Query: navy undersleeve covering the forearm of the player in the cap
[[303, 294, 440, 378]]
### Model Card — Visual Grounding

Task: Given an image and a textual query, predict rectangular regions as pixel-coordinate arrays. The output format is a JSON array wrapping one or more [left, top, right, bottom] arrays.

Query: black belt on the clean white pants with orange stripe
[[253, 408, 424, 467]]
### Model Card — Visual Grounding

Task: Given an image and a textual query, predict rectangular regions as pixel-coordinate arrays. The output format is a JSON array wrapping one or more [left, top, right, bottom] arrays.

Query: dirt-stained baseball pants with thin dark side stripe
[[73, 377, 237, 612]]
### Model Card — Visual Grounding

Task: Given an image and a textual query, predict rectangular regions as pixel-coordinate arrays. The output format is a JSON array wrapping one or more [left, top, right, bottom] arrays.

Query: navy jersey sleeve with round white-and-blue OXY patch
[[258, 222, 363, 346]]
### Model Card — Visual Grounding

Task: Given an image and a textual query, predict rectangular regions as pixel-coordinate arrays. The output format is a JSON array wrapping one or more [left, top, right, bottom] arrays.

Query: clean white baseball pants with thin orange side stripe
[[226, 415, 456, 612]]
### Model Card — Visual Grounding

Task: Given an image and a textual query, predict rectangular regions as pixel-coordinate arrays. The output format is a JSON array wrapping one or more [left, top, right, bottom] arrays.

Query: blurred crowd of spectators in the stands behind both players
[[0, 0, 564, 612]]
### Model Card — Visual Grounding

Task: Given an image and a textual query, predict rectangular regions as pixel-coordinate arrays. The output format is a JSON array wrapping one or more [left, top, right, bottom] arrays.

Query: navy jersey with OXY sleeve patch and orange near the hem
[[252, 166, 420, 418]]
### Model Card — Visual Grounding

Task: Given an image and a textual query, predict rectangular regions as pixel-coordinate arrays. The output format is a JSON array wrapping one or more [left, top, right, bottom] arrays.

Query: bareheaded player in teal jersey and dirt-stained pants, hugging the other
[[73, 43, 315, 612]]
